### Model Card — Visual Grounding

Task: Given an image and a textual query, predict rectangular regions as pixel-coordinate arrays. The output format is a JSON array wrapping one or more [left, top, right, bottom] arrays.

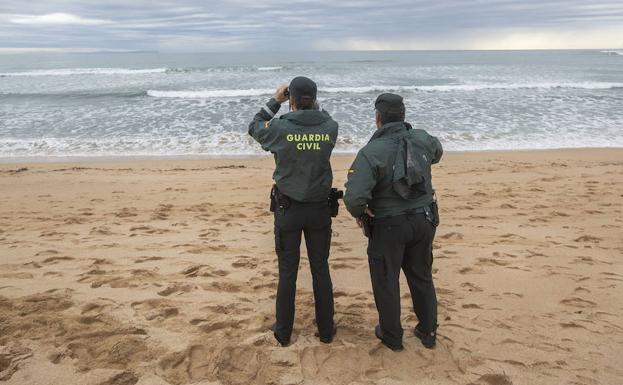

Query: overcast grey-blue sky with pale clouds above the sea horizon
[[0, 0, 623, 52]]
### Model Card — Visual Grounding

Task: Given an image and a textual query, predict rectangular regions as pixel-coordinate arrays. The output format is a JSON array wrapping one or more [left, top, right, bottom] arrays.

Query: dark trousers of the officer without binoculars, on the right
[[368, 213, 437, 346]]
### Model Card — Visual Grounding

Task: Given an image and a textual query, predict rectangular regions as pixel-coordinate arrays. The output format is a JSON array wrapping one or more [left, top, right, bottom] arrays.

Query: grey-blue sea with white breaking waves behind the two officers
[[0, 50, 623, 160]]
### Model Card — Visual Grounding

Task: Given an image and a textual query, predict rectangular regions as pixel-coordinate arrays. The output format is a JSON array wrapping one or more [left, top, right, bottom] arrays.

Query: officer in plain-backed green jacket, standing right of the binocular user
[[344, 94, 443, 351]]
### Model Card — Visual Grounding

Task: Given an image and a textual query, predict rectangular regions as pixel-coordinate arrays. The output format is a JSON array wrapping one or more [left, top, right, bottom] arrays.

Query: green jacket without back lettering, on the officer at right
[[344, 122, 443, 218]]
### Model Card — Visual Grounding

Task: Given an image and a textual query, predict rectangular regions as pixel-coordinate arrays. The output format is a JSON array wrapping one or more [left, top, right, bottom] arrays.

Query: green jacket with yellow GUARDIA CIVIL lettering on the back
[[249, 98, 338, 202]]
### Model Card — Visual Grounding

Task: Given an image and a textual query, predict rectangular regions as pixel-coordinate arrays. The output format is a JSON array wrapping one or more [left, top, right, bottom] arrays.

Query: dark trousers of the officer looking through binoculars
[[274, 201, 334, 340]]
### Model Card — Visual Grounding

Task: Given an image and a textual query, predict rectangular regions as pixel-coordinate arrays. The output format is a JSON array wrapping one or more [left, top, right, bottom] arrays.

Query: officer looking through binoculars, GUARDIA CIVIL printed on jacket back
[[249, 77, 338, 346]]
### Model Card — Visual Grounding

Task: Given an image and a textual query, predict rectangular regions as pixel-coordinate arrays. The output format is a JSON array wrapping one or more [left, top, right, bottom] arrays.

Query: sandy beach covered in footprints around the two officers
[[0, 149, 623, 385]]
